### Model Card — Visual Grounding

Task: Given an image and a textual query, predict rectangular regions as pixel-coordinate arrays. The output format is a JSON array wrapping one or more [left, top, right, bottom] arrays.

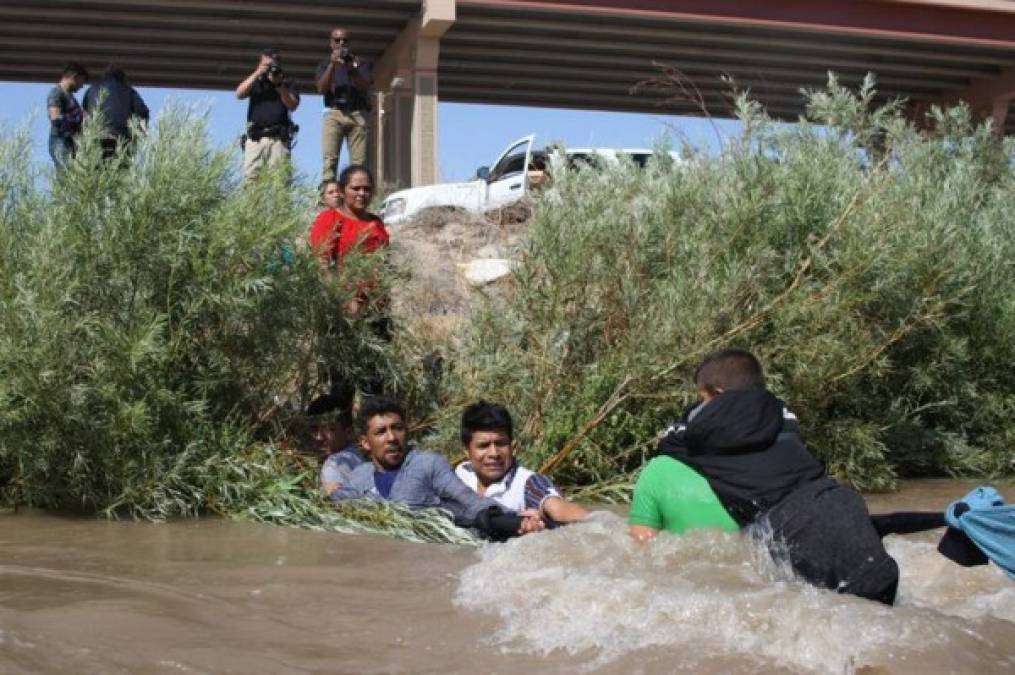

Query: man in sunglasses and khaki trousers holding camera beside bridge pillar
[[317, 28, 373, 181]]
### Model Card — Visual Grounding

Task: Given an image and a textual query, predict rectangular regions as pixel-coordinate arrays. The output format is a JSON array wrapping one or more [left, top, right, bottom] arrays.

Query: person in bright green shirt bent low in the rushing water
[[627, 457, 740, 541]]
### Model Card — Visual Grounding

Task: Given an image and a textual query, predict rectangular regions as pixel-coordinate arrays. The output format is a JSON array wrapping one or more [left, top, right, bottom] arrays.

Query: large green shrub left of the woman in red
[[0, 105, 390, 518]]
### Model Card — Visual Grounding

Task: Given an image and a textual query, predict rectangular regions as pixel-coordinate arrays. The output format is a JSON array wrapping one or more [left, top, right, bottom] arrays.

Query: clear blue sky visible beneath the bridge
[[0, 82, 737, 181]]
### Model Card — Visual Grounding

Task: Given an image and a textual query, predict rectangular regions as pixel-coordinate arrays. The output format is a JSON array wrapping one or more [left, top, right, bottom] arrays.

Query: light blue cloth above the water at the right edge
[[945, 487, 1015, 580]]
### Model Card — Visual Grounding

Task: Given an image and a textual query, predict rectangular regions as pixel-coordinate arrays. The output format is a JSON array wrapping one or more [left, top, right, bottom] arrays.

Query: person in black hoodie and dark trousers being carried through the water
[[659, 349, 899, 605]]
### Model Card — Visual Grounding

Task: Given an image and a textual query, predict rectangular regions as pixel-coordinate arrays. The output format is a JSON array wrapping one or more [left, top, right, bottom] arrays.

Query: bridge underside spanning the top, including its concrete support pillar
[[0, 0, 1015, 185]]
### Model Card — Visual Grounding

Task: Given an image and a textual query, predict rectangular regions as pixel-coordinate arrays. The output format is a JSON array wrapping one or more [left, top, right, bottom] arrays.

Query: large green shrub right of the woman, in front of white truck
[[430, 78, 1015, 494]]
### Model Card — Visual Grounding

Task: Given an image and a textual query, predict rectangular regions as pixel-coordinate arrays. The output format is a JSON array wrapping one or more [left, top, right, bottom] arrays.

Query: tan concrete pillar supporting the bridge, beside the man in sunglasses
[[371, 0, 455, 187]]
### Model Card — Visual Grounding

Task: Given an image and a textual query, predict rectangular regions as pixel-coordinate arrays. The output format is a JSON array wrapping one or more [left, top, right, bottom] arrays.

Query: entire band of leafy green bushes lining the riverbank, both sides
[[0, 80, 1015, 543]]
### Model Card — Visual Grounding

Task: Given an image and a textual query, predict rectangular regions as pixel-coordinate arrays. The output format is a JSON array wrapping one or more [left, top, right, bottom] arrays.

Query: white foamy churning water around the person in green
[[456, 513, 1015, 673]]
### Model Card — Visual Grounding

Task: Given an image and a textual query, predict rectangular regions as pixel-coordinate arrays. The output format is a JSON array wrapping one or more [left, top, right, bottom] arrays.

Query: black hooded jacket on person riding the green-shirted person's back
[[659, 389, 825, 525]]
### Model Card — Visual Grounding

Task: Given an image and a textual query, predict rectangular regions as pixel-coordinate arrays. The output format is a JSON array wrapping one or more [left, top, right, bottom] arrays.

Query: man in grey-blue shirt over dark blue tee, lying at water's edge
[[331, 396, 543, 538]]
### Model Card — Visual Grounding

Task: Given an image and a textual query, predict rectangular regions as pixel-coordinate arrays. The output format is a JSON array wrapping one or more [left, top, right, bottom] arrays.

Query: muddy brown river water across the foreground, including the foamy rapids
[[0, 481, 1015, 675]]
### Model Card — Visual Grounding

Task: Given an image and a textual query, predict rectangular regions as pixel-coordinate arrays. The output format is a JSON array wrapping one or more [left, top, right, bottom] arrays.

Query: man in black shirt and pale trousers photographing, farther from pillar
[[236, 49, 299, 182]]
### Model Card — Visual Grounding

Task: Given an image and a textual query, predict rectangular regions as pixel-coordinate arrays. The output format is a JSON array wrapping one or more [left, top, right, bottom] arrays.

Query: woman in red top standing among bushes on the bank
[[311, 164, 389, 317]]
